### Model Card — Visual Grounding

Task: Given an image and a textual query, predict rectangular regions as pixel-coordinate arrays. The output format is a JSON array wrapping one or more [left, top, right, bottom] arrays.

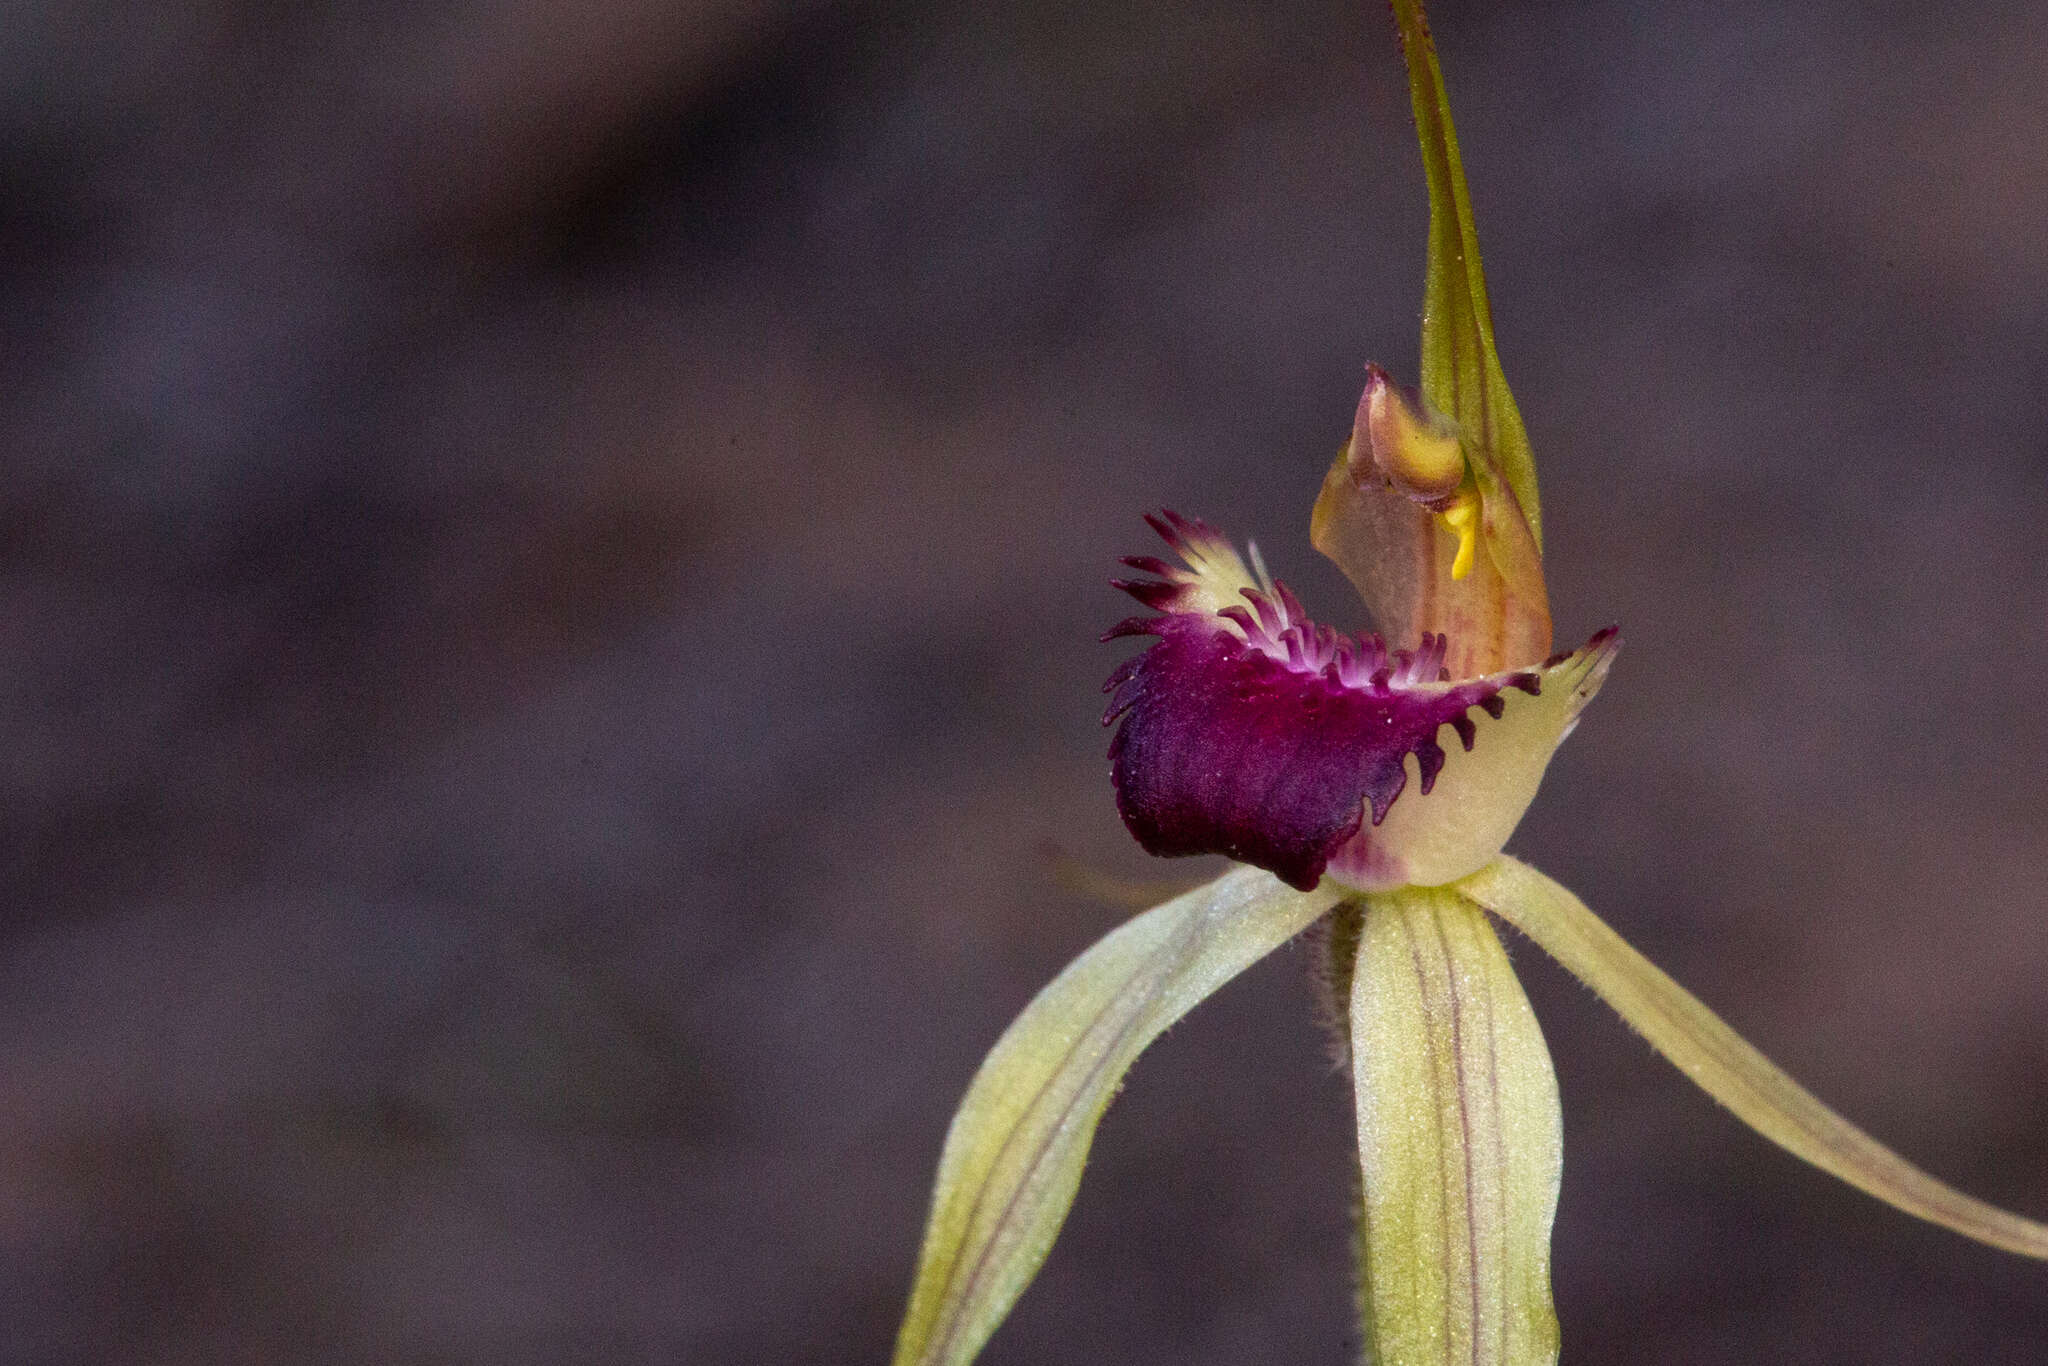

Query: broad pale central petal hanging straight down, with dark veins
[[1352, 887, 1563, 1366]]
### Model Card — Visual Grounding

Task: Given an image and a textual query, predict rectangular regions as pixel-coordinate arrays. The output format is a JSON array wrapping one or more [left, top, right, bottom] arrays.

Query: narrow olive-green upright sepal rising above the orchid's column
[[1393, 0, 1542, 549]]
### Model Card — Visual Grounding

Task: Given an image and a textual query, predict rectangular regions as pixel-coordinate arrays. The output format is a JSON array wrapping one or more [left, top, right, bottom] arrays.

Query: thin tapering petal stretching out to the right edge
[[1458, 854, 2048, 1257]]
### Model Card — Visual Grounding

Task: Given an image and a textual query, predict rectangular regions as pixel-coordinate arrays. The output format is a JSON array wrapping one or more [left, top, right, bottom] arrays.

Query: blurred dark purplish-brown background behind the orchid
[[0, 0, 2048, 1366]]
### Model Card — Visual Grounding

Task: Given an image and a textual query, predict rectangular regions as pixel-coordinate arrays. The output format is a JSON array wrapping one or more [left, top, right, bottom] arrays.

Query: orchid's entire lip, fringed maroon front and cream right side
[[1104, 514, 1620, 891]]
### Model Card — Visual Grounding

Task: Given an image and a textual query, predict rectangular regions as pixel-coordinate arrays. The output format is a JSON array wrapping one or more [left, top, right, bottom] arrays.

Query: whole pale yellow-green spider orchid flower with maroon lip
[[895, 0, 2048, 1366]]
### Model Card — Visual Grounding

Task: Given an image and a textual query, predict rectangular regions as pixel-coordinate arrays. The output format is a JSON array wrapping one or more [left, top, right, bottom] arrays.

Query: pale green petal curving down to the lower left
[[895, 868, 1341, 1366]]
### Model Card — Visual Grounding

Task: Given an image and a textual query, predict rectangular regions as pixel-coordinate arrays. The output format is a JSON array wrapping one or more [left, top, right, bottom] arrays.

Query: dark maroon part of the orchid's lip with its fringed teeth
[[1102, 512, 1540, 891]]
